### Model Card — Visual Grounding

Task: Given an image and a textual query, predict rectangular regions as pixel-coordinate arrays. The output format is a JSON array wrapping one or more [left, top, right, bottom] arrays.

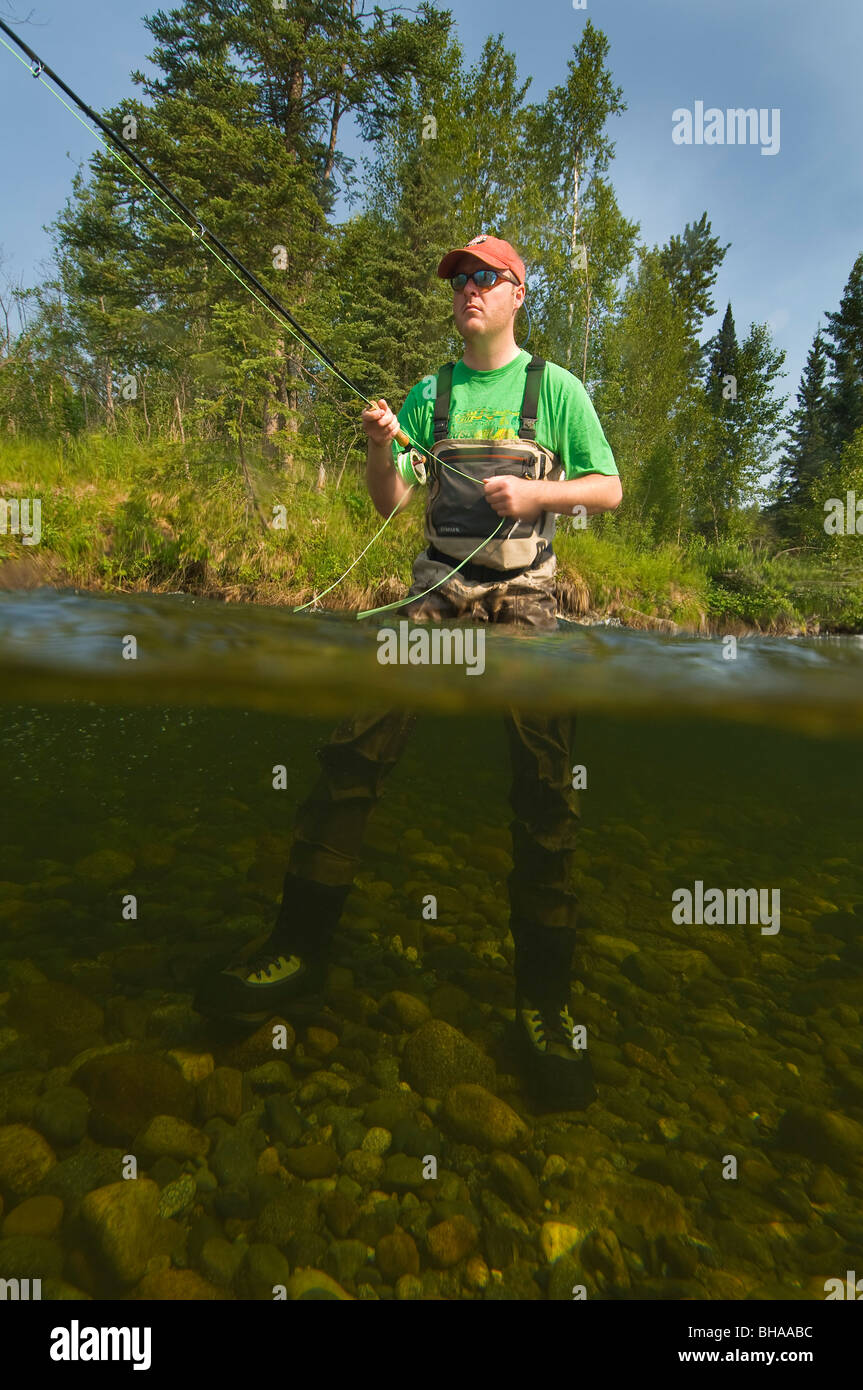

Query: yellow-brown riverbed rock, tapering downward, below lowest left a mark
[[81, 1177, 160, 1286]]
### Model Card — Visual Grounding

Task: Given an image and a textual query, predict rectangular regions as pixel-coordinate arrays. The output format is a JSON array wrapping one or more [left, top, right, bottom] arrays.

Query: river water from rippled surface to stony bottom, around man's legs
[[0, 591, 863, 1300]]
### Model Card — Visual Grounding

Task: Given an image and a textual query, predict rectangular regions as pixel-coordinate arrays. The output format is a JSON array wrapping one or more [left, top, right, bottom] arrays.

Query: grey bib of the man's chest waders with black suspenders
[[425, 357, 563, 581]]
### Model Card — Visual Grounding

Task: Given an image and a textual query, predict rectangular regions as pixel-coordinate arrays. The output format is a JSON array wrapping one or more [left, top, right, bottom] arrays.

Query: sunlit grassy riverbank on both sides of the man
[[0, 435, 863, 634]]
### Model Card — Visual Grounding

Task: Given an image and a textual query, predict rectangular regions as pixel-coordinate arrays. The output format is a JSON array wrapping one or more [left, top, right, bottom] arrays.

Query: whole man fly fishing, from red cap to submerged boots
[[196, 236, 623, 1108]]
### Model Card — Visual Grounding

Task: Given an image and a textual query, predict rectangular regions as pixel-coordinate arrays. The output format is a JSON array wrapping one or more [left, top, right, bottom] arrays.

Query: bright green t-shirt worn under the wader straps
[[393, 349, 617, 482]]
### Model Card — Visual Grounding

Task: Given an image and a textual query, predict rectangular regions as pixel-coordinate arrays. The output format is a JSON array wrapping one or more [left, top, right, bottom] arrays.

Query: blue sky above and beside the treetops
[[0, 0, 863, 411]]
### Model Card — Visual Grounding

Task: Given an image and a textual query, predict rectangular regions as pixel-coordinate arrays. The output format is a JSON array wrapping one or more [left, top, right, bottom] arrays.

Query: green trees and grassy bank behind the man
[[0, 0, 863, 631]]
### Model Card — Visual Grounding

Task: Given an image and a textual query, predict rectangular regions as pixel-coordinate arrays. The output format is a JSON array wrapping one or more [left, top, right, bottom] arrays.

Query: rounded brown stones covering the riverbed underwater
[[0, 788, 863, 1301]]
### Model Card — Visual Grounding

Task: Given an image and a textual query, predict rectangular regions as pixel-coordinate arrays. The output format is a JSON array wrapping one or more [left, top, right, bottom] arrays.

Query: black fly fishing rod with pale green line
[[0, 19, 506, 619]]
